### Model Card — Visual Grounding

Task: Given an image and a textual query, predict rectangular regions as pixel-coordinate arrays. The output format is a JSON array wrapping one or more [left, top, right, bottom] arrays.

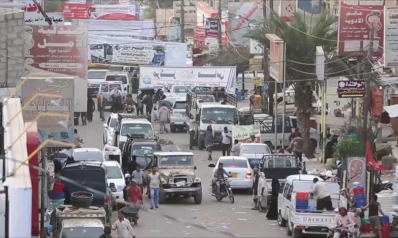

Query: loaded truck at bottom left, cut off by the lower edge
[[50, 205, 106, 238]]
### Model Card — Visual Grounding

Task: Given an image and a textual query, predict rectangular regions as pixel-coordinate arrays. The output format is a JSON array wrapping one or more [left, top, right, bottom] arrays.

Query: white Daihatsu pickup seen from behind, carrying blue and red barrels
[[278, 174, 340, 237]]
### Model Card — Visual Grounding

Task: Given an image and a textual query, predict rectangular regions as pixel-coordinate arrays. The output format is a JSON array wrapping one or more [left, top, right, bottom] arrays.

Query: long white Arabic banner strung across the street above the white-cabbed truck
[[140, 66, 236, 92]]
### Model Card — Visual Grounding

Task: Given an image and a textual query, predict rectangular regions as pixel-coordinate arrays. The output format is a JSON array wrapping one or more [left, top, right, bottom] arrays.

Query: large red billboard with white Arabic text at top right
[[337, 0, 384, 57]]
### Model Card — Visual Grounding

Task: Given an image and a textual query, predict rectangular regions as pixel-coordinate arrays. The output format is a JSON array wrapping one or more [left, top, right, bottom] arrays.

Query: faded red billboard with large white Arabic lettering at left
[[25, 26, 88, 112]]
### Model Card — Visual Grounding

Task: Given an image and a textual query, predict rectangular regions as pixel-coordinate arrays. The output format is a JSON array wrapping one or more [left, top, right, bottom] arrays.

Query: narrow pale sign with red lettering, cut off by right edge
[[384, 7, 398, 68]]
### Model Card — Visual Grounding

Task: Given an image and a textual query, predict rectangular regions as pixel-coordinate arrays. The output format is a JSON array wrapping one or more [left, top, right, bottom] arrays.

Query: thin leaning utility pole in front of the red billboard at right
[[362, 26, 375, 155]]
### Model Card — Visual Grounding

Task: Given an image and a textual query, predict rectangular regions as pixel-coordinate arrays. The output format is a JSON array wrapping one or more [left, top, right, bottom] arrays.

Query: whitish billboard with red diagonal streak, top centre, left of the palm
[[228, 2, 263, 47]]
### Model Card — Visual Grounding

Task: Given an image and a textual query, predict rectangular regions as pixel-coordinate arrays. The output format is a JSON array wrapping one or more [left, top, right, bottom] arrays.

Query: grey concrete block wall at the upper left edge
[[0, 8, 25, 88]]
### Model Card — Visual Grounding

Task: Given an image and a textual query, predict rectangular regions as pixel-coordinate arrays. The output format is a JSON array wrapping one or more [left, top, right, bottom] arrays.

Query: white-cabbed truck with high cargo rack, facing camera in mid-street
[[185, 87, 239, 150]]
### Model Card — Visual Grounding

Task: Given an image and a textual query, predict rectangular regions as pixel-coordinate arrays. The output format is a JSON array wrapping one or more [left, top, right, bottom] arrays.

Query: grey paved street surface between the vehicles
[[77, 102, 287, 238]]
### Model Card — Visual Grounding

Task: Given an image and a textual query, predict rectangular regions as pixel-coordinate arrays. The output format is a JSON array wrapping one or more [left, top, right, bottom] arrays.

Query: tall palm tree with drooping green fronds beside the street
[[247, 12, 355, 156]]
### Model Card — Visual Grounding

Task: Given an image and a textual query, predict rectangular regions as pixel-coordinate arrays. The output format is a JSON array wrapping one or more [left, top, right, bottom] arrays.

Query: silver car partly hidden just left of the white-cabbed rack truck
[[170, 98, 188, 132]]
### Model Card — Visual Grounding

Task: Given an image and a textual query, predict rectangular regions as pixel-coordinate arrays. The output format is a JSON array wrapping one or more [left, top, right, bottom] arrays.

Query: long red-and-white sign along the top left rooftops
[[62, 3, 136, 21]]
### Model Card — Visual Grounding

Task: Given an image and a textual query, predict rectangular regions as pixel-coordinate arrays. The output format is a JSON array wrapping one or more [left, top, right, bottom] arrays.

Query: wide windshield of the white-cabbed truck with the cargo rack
[[202, 107, 236, 124]]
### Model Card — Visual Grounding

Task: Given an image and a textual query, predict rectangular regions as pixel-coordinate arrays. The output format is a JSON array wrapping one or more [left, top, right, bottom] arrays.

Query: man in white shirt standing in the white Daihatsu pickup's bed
[[310, 178, 334, 211]]
